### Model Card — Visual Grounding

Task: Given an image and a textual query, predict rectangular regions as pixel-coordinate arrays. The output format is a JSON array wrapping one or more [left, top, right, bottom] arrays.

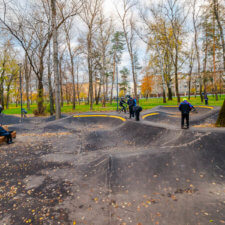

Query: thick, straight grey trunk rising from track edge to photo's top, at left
[[51, 0, 61, 119]]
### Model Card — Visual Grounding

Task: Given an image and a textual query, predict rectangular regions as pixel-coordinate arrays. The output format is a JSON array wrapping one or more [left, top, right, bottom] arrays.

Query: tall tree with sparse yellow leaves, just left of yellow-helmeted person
[[137, 4, 175, 103]]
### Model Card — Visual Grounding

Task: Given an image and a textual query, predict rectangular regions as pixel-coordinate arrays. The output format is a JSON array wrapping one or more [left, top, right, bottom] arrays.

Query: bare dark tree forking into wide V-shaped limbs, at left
[[0, 0, 81, 117]]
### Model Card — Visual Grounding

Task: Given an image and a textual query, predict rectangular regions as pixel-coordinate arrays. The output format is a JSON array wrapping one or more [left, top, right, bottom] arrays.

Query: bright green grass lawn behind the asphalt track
[[3, 95, 225, 114]]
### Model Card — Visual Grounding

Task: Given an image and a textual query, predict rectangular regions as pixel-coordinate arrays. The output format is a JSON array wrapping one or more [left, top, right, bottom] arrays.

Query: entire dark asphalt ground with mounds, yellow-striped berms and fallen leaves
[[0, 107, 225, 225]]
